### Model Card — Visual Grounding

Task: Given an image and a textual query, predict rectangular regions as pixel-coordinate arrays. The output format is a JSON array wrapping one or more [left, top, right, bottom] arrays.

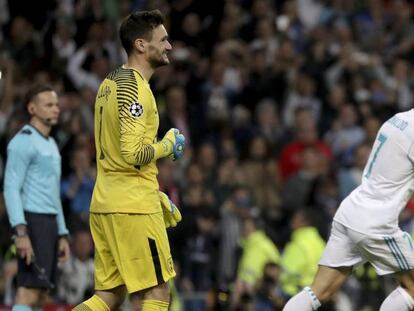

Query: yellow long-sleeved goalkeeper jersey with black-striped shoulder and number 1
[[90, 67, 161, 214]]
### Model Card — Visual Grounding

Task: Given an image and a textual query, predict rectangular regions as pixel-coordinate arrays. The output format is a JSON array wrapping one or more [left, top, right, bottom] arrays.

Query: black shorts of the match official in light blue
[[17, 212, 59, 289]]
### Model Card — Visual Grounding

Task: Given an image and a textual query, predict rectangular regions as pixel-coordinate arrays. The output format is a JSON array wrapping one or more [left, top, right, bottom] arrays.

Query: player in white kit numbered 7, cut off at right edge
[[283, 109, 414, 311]]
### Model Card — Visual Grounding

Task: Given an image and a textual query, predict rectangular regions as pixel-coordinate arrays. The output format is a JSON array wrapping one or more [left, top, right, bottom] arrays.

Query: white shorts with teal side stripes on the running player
[[319, 221, 414, 275]]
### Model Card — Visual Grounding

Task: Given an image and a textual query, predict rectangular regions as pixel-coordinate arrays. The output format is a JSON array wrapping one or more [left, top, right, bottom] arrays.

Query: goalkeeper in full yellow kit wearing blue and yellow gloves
[[74, 10, 185, 311]]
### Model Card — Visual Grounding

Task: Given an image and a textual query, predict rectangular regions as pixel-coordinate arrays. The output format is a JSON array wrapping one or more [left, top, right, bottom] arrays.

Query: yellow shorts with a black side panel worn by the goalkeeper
[[90, 212, 175, 293]]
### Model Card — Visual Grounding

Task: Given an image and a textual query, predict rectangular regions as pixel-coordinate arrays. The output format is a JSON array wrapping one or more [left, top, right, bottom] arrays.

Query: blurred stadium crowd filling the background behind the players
[[0, 0, 414, 310]]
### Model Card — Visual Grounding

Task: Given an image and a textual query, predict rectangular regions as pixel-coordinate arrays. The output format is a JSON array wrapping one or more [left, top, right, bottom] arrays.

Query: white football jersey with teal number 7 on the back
[[334, 109, 414, 235]]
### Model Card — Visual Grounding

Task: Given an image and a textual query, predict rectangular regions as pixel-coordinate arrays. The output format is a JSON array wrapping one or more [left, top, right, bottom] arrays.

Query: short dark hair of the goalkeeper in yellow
[[119, 10, 164, 55]]
